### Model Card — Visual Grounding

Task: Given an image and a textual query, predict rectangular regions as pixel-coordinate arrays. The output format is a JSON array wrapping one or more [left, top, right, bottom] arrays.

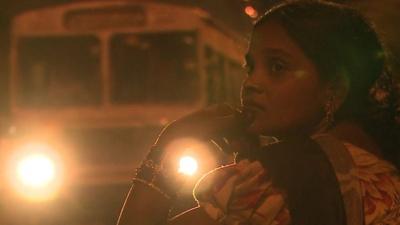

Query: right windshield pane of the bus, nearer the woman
[[111, 32, 199, 104]]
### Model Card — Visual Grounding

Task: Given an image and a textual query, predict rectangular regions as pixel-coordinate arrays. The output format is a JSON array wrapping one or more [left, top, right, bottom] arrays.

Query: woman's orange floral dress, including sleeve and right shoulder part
[[194, 135, 400, 225]]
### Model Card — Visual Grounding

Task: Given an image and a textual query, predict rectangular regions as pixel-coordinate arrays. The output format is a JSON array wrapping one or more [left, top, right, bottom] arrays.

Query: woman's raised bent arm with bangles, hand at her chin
[[118, 105, 244, 225]]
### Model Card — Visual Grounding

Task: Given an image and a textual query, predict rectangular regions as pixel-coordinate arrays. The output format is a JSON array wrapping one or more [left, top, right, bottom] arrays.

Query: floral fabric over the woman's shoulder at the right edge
[[344, 143, 400, 225]]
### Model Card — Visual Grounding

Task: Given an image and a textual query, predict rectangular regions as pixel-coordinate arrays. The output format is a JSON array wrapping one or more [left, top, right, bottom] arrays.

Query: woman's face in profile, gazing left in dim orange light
[[242, 21, 326, 136]]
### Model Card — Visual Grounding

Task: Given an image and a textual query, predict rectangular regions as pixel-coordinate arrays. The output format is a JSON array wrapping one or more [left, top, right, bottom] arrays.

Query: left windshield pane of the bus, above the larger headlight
[[18, 36, 101, 107]]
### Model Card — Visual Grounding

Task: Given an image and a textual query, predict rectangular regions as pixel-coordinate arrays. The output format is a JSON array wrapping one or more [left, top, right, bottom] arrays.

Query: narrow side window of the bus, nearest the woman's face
[[205, 47, 226, 104]]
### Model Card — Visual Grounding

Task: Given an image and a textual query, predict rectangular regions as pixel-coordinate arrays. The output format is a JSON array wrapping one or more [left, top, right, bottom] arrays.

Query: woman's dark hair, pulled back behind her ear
[[255, 0, 400, 165]]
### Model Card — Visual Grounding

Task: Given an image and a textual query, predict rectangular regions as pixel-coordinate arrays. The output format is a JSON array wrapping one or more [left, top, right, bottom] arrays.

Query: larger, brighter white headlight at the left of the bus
[[17, 154, 55, 188]]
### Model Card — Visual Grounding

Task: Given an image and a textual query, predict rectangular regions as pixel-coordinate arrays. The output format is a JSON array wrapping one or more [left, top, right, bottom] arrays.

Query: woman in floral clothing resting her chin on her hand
[[119, 0, 400, 225]]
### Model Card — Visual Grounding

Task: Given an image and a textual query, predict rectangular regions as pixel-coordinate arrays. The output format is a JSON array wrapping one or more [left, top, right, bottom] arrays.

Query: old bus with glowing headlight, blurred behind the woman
[[2, 1, 245, 225]]
